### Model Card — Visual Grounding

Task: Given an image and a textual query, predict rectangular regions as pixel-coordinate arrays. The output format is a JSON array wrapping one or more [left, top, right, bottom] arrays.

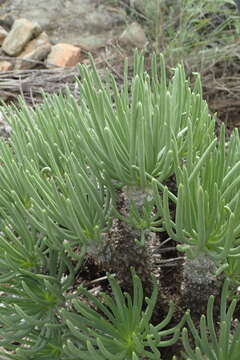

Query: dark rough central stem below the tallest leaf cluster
[[89, 189, 159, 295]]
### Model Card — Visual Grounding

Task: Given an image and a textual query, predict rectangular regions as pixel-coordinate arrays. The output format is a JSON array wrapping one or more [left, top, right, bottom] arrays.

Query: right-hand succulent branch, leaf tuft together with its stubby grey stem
[[159, 126, 240, 312]]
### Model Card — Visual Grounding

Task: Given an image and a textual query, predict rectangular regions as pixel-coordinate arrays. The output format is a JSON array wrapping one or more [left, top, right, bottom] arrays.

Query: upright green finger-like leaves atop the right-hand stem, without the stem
[[160, 126, 240, 277]]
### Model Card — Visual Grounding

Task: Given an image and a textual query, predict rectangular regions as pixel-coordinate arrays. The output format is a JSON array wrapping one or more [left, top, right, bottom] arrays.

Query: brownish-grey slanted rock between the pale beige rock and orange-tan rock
[[15, 32, 51, 70]]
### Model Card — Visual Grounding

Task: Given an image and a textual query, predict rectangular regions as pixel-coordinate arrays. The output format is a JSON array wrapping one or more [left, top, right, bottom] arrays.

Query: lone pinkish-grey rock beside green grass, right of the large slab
[[119, 22, 147, 48]]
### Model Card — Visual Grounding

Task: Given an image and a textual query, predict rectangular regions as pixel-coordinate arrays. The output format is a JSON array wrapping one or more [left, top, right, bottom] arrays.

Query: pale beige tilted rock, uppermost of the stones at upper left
[[2, 19, 41, 56]]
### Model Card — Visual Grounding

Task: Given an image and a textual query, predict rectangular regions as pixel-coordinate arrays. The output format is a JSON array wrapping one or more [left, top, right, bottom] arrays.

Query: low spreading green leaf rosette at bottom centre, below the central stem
[[61, 270, 185, 360]]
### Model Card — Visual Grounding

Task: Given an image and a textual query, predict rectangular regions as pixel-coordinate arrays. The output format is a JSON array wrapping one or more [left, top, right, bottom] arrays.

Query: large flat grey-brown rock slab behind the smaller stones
[[0, 0, 126, 50]]
